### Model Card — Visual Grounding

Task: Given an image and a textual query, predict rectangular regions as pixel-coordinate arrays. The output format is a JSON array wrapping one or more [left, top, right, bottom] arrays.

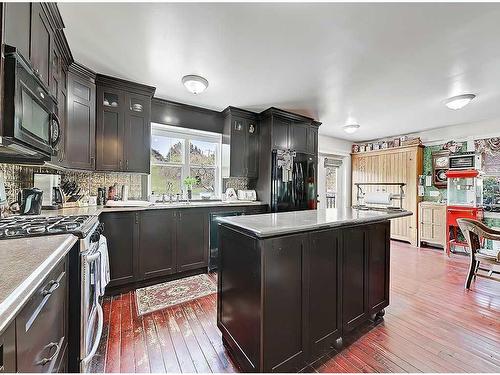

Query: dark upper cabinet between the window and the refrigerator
[[223, 107, 259, 178]]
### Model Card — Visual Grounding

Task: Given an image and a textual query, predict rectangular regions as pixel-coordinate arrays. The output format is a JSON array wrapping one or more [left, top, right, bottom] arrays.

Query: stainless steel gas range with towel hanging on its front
[[0, 215, 109, 372]]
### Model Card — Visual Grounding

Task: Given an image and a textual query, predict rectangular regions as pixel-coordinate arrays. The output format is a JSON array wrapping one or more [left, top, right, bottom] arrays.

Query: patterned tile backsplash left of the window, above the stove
[[0, 163, 142, 203]]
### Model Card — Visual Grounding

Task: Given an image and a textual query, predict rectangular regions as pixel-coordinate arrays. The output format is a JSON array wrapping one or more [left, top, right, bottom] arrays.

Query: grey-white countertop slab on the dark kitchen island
[[217, 208, 412, 237]]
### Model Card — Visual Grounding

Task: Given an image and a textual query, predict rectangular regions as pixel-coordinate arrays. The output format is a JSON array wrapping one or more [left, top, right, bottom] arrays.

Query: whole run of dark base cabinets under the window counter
[[101, 208, 209, 289]]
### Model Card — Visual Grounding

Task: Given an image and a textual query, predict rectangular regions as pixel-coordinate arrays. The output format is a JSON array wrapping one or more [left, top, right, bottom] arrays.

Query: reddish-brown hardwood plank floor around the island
[[93, 242, 500, 372]]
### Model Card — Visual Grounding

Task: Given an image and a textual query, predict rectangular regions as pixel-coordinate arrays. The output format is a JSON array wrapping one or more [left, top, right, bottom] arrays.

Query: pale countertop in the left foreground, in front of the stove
[[0, 234, 78, 332]]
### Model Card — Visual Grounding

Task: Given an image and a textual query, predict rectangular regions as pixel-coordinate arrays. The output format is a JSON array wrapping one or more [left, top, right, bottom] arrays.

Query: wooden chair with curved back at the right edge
[[457, 219, 500, 289]]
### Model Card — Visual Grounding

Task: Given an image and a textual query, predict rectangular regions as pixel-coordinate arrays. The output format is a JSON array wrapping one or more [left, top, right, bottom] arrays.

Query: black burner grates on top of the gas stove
[[0, 215, 97, 239]]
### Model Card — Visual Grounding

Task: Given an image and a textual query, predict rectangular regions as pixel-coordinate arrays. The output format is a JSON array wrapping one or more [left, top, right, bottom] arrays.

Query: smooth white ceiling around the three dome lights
[[59, 3, 500, 141]]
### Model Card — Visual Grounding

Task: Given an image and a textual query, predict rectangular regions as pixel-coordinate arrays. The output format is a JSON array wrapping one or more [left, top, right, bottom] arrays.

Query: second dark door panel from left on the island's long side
[[305, 230, 342, 356]]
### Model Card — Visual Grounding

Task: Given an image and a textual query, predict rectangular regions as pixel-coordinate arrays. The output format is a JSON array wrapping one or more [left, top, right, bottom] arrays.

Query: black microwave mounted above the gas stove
[[0, 50, 61, 160]]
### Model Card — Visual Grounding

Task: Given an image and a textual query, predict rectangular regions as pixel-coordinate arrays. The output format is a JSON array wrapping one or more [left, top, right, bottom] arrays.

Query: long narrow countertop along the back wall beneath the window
[[42, 201, 263, 216]]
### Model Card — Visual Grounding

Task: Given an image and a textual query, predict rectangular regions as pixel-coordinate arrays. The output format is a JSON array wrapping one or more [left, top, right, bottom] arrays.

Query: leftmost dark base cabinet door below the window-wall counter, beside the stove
[[101, 212, 139, 288]]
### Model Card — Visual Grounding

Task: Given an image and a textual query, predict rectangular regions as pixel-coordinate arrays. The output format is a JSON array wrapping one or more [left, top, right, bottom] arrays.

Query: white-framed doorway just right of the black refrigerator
[[318, 154, 344, 208]]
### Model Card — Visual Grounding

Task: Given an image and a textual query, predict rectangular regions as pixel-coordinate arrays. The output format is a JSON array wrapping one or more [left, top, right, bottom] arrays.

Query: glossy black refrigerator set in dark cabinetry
[[271, 150, 317, 212]]
